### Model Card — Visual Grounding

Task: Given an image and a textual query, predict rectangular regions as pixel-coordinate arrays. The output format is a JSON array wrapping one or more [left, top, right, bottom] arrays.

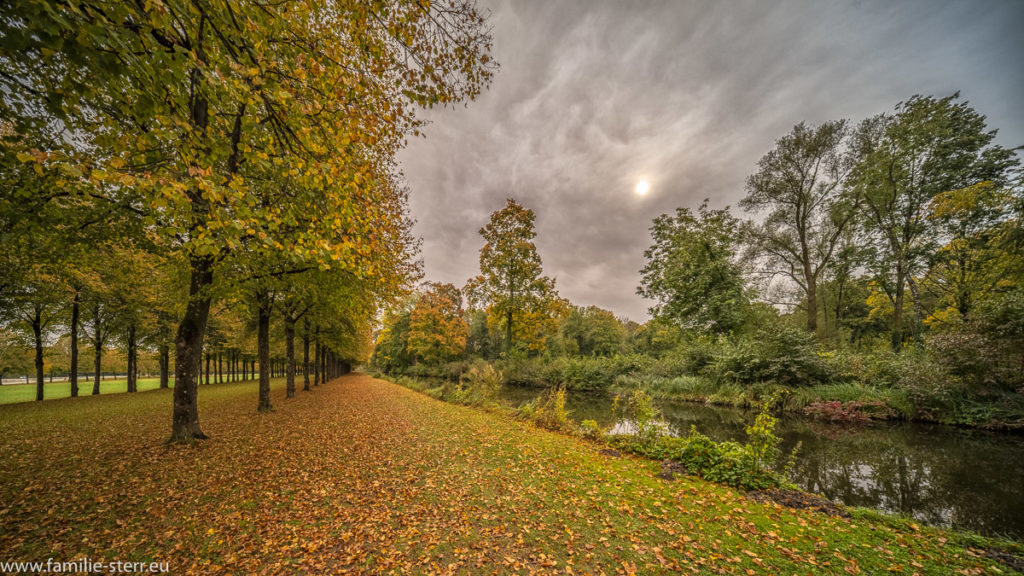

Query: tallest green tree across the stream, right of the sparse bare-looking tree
[[850, 93, 1017, 349]]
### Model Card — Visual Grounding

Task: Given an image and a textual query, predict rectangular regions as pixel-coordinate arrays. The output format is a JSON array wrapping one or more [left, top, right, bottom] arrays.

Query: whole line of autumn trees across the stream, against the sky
[[376, 94, 1024, 399]]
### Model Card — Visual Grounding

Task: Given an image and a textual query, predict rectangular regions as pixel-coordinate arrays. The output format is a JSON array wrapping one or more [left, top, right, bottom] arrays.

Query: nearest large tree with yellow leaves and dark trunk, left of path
[[0, 0, 494, 441]]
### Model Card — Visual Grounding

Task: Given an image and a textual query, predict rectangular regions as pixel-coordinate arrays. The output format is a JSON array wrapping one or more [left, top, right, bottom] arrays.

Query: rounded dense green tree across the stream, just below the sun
[[637, 200, 750, 333]]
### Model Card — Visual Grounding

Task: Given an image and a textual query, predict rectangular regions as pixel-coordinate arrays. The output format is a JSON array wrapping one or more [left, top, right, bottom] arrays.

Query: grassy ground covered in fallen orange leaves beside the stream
[[0, 374, 1008, 574]]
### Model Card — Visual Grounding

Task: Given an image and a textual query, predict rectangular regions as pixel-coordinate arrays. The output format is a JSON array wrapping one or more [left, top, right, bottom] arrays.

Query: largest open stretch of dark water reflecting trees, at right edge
[[783, 416, 1024, 535]]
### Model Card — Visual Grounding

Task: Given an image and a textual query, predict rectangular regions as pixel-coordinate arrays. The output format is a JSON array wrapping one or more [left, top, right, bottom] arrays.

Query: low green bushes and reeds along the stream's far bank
[[374, 347, 1024, 433]]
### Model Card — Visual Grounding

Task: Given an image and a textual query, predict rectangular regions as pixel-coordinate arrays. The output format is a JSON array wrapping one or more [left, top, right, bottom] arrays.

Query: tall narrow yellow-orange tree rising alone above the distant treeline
[[467, 198, 557, 354]]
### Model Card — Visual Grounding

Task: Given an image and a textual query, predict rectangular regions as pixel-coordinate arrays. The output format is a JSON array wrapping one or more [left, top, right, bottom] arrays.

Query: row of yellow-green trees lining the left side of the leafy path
[[0, 0, 494, 441]]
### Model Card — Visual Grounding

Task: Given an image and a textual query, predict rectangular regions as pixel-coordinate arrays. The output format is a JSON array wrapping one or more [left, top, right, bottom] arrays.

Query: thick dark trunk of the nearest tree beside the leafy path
[[170, 256, 213, 442]]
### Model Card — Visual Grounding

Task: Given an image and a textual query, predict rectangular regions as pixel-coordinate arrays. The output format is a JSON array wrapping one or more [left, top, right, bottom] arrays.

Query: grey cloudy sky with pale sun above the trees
[[401, 0, 1024, 321]]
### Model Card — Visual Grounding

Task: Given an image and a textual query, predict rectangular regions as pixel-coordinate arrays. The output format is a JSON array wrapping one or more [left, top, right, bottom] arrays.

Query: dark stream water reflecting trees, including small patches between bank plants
[[502, 387, 1024, 539]]
